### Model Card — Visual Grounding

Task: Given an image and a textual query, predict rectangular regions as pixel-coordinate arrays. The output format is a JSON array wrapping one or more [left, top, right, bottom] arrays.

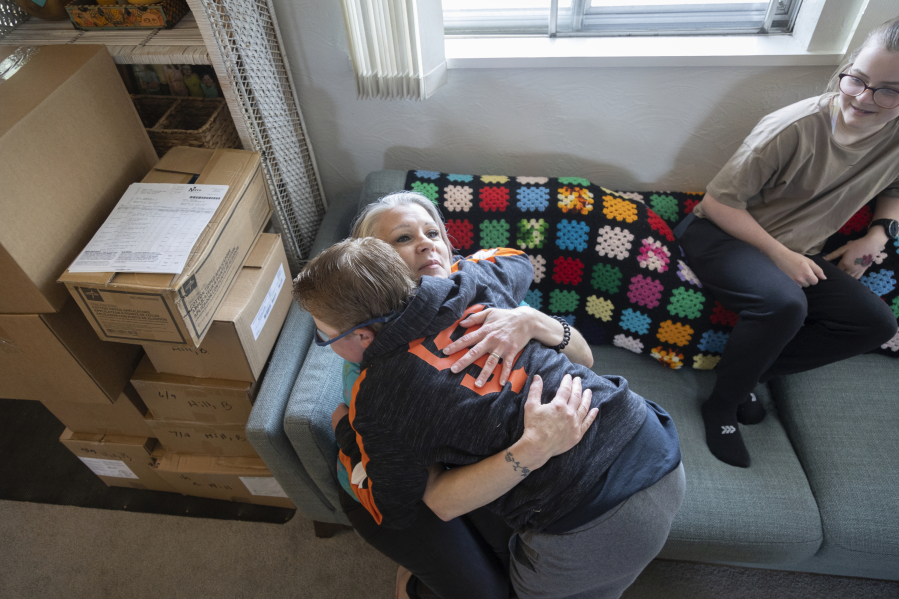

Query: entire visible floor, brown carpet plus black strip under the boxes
[[0, 400, 899, 599]]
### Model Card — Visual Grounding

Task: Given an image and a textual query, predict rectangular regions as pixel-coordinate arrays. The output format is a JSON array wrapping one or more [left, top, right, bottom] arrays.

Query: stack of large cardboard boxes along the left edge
[[0, 46, 163, 490]]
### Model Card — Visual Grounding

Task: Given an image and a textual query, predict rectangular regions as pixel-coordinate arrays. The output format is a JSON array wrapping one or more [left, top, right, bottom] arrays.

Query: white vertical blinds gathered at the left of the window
[[342, 0, 446, 100]]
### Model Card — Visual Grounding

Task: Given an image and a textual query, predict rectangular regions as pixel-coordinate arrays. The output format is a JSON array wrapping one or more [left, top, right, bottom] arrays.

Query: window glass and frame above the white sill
[[443, 0, 801, 37]]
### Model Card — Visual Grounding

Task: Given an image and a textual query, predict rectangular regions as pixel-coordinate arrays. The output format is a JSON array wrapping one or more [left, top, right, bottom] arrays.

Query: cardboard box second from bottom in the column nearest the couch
[[147, 410, 259, 458]]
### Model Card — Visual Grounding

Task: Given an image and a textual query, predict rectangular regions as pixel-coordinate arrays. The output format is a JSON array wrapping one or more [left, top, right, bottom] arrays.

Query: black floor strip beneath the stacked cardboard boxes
[[0, 399, 295, 523]]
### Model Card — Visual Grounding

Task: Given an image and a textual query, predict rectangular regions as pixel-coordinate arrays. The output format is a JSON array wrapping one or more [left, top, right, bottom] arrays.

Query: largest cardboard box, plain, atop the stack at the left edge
[[0, 45, 157, 314]]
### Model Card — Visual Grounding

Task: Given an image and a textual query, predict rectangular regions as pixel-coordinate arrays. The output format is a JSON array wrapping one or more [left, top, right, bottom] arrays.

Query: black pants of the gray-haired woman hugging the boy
[[340, 490, 512, 599]]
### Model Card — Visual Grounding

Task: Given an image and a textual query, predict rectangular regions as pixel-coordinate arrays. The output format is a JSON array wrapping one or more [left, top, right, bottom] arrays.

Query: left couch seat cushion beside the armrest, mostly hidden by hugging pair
[[284, 343, 349, 524]]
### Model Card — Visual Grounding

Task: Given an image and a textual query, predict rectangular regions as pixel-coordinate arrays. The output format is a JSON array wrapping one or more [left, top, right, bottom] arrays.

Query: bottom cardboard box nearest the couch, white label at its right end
[[154, 451, 294, 509]]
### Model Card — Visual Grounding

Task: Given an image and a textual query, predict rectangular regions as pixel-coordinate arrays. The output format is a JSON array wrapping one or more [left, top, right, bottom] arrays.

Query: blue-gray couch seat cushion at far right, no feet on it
[[771, 354, 899, 580]]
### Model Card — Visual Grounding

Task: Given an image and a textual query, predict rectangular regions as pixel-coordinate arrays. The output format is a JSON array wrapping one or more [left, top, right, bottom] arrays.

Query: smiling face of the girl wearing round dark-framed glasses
[[840, 43, 899, 135]]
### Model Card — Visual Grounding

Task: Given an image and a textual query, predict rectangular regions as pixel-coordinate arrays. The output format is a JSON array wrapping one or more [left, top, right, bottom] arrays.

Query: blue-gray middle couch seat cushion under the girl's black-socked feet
[[593, 346, 821, 567]]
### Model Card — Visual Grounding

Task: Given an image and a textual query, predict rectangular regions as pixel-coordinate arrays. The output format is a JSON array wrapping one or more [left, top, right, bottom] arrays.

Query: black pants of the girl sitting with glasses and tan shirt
[[680, 218, 897, 404]]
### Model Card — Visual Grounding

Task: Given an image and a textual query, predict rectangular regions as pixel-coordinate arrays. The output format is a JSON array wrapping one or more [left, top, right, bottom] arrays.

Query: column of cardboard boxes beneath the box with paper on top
[[131, 233, 293, 507]]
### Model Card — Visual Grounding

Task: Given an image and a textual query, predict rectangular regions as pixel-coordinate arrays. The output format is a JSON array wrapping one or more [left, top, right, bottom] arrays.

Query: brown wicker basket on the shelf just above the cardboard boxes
[[131, 95, 241, 156]]
